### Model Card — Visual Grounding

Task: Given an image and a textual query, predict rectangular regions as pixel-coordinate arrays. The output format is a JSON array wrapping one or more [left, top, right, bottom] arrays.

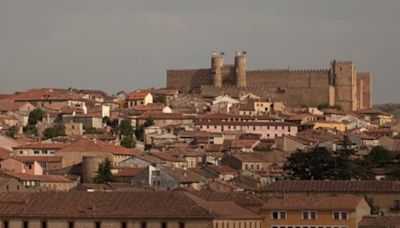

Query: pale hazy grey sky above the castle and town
[[0, 0, 400, 103]]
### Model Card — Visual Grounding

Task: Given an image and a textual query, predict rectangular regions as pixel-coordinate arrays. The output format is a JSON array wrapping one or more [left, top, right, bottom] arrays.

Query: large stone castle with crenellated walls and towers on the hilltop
[[167, 52, 371, 111]]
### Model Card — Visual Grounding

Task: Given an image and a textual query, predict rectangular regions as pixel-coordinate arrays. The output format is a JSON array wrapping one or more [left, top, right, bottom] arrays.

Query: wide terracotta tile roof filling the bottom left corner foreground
[[0, 191, 213, 219]]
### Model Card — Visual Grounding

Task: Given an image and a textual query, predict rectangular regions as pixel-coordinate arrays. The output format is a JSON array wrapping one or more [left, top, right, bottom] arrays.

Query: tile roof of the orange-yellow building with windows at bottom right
[[263, 195, 363, 211]]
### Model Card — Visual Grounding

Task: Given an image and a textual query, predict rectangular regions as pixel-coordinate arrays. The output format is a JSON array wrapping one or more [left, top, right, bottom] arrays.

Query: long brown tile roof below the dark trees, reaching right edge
[[263, 180, 400, 193]]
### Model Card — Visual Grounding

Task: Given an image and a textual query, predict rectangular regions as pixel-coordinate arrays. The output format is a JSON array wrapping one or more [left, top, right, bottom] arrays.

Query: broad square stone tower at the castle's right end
[[331, 60, 358, 111]]
